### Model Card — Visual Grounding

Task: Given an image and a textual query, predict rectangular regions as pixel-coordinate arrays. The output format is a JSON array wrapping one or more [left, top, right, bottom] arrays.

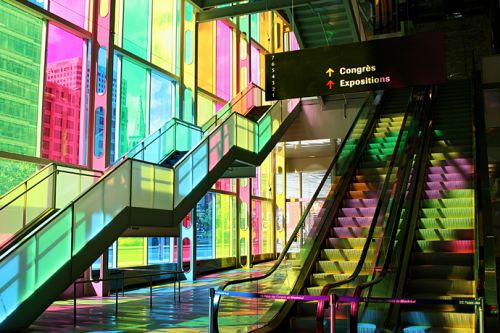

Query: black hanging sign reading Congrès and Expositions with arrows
[[266, 32, 446, 100]]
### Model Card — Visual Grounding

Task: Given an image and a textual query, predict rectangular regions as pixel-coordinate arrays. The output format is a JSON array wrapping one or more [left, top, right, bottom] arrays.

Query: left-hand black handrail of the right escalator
[[350, 85, 430, 332]]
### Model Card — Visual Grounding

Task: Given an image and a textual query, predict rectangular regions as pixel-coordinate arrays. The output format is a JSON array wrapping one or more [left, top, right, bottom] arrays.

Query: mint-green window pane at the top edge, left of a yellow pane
[[123, 0, 149, 59]]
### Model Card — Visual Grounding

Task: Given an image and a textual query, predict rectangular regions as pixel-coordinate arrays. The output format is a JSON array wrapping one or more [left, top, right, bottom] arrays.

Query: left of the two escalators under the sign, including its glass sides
[[213, 89, 417, 332]]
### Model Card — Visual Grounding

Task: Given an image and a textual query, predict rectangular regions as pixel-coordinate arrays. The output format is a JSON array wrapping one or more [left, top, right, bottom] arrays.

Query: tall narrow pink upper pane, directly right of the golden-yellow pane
[[216, 21, 232, 101]]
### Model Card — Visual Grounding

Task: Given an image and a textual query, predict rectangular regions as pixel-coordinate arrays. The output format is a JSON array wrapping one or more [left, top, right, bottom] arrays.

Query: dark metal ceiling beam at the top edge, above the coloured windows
[[196, 0, 318, 22]]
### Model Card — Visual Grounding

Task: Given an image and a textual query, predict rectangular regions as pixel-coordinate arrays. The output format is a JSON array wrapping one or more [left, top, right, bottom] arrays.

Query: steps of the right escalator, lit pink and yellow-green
[[400, 81, 477, 332]]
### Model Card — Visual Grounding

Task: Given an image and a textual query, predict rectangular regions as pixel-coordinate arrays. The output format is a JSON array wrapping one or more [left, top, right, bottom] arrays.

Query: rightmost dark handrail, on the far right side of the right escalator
[[471, 53, 498, 324]]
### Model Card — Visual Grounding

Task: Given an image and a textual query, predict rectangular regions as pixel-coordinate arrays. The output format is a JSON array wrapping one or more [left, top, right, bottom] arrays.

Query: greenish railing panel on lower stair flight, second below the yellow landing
[[73, 182, 104, 254]]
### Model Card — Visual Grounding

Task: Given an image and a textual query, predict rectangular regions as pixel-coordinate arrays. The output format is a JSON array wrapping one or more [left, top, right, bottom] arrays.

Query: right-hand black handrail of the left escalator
[[316, 89, 414, 332]]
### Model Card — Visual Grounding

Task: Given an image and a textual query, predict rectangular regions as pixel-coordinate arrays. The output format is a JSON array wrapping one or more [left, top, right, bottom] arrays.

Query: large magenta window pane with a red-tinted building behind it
[[42, 24, 86, 164]]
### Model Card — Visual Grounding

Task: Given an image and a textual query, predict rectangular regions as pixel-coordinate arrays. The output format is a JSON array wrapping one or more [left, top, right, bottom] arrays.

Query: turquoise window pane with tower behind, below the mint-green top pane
[[119, 58, 147, 156]]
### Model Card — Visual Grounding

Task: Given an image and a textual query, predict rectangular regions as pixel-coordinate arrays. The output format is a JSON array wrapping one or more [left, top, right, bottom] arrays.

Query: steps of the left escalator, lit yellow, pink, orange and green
[[290, 90, 410, 332]]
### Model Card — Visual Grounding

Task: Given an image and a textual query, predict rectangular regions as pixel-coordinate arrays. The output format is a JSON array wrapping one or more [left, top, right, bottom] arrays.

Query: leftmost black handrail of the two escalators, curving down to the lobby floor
[[212, 94, 375, 330]]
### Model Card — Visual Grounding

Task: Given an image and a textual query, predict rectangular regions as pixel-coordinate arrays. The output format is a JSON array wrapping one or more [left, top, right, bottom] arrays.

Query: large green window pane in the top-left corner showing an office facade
[[0, 1, 42, 156]]
